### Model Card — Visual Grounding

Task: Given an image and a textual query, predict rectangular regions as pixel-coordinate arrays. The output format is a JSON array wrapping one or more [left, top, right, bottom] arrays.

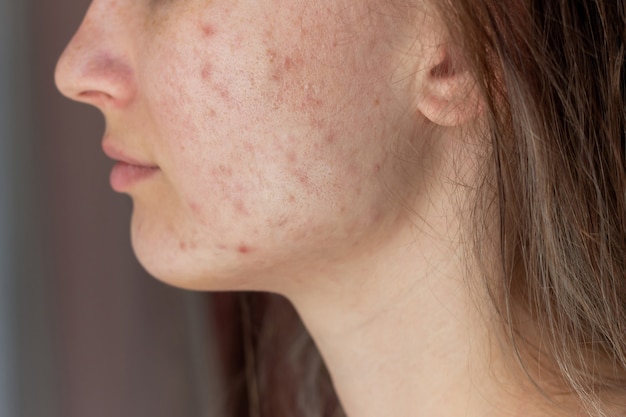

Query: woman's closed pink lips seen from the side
[[102, 141, 160, 192]]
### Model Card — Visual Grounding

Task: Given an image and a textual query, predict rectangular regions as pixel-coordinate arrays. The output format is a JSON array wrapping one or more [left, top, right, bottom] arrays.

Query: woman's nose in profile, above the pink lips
[[55, 0, 136, 111]]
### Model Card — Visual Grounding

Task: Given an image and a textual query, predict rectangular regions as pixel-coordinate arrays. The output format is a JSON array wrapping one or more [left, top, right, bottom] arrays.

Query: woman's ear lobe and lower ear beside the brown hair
[[417, 45, 483, 127]]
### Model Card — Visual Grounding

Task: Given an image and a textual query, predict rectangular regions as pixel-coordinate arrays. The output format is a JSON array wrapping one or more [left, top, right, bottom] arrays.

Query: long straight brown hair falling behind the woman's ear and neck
[[239, 0, 626, 416]]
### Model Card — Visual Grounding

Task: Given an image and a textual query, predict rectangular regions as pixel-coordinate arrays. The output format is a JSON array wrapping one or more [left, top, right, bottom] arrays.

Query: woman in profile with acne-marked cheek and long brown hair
[[56, 0, 626, 417]]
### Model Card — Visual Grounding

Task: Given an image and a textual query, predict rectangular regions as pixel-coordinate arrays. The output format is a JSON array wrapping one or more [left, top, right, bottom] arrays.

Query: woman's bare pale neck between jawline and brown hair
[[280, 164, 552, 417]]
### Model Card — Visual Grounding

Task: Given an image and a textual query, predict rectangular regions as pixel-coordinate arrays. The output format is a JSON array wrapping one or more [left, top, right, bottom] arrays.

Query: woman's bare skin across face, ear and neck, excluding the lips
[[56, 0, 568, 417]]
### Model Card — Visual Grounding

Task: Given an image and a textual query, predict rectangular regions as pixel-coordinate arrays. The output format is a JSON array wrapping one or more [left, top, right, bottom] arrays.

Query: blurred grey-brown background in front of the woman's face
[[0, 0, 234, 417]]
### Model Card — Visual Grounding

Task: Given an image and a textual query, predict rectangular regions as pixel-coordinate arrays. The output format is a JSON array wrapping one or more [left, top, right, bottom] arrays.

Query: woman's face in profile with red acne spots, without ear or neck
[[57, 0, 428, 289]]
